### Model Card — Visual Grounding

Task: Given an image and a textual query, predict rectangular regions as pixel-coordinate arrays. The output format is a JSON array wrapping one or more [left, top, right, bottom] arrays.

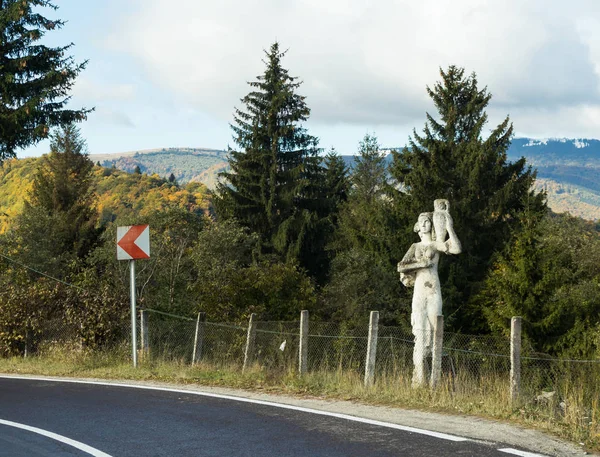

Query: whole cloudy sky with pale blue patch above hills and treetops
[[18, 0, 600, 157]]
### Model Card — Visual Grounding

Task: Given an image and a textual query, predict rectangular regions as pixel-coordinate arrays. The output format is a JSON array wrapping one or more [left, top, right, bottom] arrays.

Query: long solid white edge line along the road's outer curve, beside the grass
[[0, 375, 471, 441]]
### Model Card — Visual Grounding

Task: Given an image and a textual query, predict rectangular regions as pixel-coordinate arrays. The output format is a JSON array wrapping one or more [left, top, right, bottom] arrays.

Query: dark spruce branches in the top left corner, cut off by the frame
[[0, 0, 91, 162]]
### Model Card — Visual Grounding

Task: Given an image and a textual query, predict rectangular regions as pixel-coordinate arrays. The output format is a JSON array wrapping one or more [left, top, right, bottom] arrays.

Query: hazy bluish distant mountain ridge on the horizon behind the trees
[[90, 138, 600, 220]]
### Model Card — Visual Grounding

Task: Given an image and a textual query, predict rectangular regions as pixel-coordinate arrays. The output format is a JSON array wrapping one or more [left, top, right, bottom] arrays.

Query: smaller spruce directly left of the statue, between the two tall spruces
[[323, 134, 405, 325]]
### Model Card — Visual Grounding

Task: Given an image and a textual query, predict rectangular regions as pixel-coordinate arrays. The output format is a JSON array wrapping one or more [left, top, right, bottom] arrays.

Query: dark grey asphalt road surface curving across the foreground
[[0, 378, 544, 457]]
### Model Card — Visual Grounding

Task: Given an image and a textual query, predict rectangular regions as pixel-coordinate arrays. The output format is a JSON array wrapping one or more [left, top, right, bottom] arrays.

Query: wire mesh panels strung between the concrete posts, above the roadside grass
[[8, 310, 600, 408]]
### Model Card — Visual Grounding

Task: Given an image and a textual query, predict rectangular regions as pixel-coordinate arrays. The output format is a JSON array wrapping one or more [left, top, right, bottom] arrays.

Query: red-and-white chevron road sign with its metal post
[[117, 225, 150, 368]]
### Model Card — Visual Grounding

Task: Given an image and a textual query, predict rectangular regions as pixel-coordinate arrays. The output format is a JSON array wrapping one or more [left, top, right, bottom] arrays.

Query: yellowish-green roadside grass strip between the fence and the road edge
[[0, 350, 600, 451]]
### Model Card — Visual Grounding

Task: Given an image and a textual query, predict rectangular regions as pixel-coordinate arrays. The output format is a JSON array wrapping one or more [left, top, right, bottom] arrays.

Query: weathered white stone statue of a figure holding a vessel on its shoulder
[[398, 199, 462, 387]]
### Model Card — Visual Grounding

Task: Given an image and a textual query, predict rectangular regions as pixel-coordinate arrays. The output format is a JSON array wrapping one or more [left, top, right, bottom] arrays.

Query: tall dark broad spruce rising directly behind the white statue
[[391, 66, 545, 332]]
